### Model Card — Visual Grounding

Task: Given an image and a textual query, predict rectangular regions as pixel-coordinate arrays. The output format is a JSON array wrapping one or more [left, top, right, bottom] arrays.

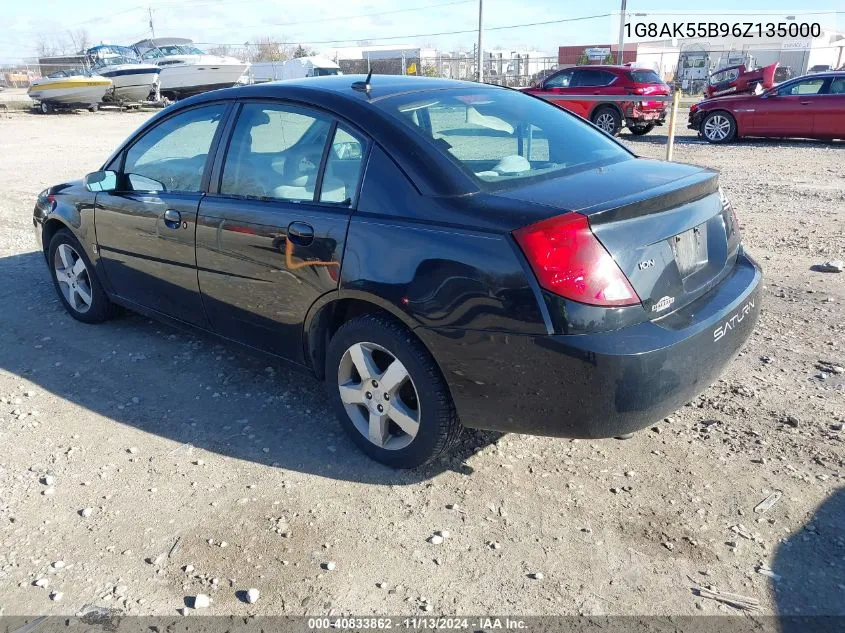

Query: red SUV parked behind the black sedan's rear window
[[525, 66, 670, 136]]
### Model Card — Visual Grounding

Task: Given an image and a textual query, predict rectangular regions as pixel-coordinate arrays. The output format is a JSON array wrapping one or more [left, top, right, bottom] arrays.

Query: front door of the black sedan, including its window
[[94, 102, 231, 327]]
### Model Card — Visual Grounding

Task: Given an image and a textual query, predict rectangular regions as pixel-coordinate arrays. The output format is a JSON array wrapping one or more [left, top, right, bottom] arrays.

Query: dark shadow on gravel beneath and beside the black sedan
[[0, 252, 501, 485]]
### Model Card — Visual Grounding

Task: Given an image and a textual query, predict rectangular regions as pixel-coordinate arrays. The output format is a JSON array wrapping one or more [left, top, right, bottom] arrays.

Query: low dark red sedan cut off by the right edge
[[689, 71, 845, 143]]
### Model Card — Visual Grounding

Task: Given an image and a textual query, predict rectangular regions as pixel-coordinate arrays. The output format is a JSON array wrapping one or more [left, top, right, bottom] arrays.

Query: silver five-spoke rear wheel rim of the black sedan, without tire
[[337, 342, 421, 450]]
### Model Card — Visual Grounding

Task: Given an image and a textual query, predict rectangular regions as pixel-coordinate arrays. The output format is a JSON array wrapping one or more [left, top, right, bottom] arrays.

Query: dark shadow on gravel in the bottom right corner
[[771, 487, 845, 633]]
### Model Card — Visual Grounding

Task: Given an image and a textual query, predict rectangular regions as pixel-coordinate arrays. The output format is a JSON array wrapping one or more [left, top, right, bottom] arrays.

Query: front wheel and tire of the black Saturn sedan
[[47, 229, 116, 323]]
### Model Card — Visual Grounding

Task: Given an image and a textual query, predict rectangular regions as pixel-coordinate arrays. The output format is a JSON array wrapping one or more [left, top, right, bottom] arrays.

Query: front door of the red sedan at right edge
[[754, 77, 826, 137]]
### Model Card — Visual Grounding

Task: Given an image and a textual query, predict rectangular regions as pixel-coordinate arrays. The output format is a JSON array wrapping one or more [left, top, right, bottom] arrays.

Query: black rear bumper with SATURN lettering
[[416, 253, 762, 438]]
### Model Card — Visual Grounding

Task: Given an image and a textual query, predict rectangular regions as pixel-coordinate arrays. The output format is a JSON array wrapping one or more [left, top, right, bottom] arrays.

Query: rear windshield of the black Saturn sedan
[[377, 88, 631, 189]]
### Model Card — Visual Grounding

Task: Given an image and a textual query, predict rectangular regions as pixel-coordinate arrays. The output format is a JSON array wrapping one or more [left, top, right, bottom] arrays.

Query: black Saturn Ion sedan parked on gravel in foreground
[[34, 76, 761, 467]]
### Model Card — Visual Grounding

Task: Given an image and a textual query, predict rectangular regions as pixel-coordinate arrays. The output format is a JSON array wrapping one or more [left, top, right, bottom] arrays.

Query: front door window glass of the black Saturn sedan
[[123, 104, 226, 193]]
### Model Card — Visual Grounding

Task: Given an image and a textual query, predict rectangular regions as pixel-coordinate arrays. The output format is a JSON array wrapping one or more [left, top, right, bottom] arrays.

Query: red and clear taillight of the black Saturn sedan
[[514, 213, 640, 306]]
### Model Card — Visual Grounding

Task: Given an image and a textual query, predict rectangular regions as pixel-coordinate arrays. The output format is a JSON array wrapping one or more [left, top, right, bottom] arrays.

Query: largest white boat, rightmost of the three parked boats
[[133, 37, 249, 99]]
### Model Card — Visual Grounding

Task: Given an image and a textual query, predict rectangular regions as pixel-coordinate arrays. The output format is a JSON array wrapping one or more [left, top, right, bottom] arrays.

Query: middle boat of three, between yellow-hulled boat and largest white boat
[[86, 44, 161, 103]]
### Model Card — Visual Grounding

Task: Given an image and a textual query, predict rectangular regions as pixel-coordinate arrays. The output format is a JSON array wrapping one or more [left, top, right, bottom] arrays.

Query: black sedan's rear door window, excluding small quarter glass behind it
[[220, 103, 331, 201]]
